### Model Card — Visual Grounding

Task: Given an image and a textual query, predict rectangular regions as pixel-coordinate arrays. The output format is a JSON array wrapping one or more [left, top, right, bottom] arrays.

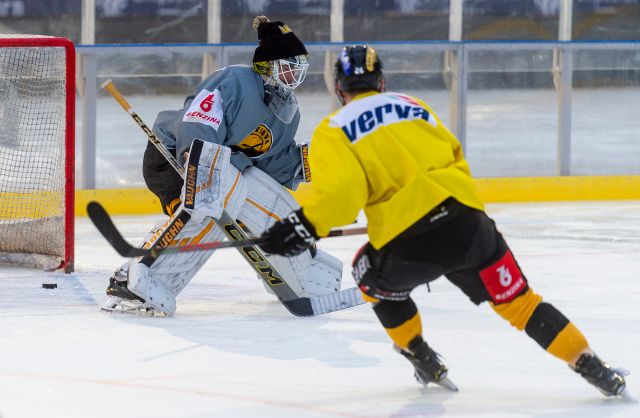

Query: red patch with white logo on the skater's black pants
[[480, 250, 527, 304]]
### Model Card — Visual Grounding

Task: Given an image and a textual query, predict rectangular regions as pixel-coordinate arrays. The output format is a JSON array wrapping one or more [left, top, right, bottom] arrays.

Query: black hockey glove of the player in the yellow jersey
[[258, 209, 319, 257]]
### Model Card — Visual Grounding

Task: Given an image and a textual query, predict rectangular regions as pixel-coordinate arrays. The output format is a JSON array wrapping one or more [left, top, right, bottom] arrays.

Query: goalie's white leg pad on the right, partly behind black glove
[[238, 167, 342, 297]]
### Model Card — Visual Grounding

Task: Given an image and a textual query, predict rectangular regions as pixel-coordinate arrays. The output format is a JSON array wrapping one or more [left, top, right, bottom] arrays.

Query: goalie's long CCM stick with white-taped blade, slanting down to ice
[[102, 80, 364, 316]]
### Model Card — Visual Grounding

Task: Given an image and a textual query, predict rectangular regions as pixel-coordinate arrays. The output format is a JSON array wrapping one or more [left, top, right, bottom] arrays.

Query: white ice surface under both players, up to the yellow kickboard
[[0, 201, 640, 418]]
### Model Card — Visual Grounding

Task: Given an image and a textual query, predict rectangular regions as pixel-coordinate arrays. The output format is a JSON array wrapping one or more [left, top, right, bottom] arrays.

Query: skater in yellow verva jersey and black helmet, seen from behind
[[261, 46, 625, 396]]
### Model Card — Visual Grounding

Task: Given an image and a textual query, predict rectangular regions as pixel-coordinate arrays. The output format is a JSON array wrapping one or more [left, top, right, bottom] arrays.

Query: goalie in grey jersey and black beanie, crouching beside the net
[[103, 16, 342, 316]]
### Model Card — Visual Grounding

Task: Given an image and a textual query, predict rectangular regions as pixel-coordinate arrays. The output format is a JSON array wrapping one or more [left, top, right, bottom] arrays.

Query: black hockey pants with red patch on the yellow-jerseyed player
[[353, 198, 528, 304]]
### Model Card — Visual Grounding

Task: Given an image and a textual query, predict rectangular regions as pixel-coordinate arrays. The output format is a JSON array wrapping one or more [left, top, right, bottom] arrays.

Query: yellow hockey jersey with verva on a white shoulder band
[[297, 92, 484, 248]]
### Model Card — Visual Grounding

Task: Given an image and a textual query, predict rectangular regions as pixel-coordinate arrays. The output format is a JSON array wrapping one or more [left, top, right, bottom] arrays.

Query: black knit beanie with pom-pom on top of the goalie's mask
[[253, 16, 308, 62]]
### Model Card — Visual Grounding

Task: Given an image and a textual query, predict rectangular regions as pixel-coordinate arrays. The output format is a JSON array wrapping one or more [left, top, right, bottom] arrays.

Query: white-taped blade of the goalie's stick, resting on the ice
[[282, 287, 365, 316]]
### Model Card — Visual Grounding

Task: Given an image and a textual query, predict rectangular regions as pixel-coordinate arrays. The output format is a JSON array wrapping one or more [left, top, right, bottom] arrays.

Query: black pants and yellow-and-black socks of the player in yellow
[[353, 198, 588, 362]]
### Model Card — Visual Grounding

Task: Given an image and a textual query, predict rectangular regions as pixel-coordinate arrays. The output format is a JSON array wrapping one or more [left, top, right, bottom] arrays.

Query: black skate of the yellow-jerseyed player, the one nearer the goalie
[[394, 336, 458, 391]]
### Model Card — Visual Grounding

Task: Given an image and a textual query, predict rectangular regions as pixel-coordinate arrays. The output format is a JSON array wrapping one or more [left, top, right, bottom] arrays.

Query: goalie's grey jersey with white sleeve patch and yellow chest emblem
[[154, 65, 302, 189]]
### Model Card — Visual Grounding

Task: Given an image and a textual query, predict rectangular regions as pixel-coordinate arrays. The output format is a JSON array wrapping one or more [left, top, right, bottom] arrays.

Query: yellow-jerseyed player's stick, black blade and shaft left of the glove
[[87, 202, 261, 257]]
